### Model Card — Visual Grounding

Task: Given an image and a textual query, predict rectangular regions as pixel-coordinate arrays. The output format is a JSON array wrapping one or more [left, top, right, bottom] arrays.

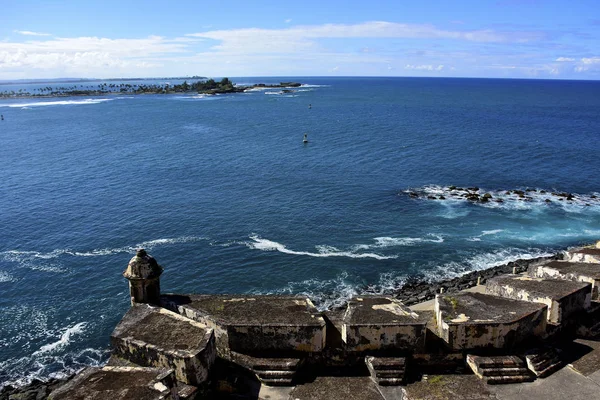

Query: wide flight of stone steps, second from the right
[[467, 354, 535, 384]]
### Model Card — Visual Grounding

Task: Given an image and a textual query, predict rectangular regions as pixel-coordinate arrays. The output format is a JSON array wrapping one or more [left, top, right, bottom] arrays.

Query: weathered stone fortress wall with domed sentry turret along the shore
[[43, 242, 600, 400]]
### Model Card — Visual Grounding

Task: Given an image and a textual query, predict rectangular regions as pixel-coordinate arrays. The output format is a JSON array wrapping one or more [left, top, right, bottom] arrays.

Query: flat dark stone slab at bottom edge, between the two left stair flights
[[290, 376, 383, 400]]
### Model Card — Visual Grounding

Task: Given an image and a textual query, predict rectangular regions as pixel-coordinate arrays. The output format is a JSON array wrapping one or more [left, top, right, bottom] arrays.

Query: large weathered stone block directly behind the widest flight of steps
[[435, 292, 547, 350]]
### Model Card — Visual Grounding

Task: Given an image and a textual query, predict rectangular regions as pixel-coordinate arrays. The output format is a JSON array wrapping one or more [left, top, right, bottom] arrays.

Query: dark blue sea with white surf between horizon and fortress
[[0, 78, 600, 386]]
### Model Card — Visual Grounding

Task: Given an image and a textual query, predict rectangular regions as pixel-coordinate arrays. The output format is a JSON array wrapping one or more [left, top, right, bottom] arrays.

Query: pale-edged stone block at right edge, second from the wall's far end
[[528, 261, 600, 300]]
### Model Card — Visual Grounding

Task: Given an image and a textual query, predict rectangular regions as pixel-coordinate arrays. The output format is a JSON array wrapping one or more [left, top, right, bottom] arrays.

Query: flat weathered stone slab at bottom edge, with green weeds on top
[[402, 375, 497, 400]]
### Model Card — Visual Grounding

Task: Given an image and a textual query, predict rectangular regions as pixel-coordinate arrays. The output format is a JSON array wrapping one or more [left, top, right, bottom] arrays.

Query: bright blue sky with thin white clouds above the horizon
[[0, 0, 600, 80]]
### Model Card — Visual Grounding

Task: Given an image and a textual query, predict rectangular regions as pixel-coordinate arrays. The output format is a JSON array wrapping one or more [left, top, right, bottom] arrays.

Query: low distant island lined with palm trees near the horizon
[[0, 78, 302, 99]]
